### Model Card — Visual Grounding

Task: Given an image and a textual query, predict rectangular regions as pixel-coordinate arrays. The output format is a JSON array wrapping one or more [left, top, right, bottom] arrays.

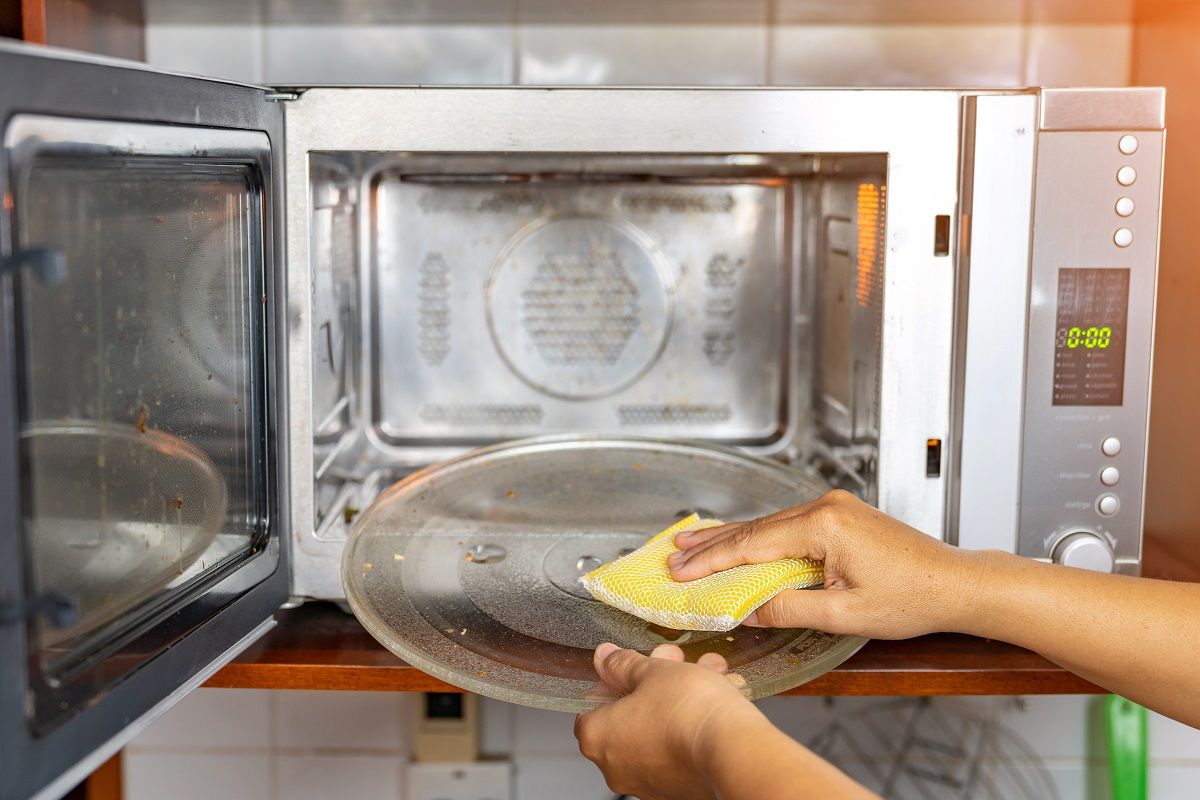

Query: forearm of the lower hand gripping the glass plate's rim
[[701, 711, 875, 800]]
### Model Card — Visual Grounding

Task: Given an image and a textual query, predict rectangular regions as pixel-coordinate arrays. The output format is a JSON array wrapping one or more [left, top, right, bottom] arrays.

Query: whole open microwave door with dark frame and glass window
[[0, 46, 288, 800]]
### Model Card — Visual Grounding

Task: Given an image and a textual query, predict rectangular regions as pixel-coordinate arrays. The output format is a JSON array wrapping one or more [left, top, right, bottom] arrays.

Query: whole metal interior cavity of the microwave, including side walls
[[308, 152, 887, 566]]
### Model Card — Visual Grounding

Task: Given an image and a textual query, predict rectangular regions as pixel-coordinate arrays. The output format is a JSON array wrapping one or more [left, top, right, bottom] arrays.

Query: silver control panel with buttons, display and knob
[[1018, 131, 1163, 573]]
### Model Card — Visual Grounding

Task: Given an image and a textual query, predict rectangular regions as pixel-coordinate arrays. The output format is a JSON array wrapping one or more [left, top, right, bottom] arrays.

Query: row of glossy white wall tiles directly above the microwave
[[146, 15, 1132, 86]]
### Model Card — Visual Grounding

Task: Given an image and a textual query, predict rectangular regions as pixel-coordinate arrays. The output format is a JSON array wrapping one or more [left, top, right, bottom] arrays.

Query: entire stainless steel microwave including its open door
[[0, 46, 1164, 800]]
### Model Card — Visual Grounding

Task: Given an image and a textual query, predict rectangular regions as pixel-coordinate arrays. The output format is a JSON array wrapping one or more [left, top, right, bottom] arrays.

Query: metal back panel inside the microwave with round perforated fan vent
[[369, 165, 797, 449]]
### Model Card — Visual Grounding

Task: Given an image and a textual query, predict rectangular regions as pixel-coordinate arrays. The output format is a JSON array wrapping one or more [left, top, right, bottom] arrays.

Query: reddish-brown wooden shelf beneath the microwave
[[205, 603, 1104, 696]]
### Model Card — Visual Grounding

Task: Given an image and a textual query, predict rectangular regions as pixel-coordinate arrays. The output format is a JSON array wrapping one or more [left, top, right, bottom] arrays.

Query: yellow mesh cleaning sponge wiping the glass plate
[[580, 515, 824, 631]]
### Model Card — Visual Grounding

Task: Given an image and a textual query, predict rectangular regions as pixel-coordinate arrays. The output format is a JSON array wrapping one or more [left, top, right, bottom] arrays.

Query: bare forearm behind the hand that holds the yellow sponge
[[947, 553, 1200, 727]]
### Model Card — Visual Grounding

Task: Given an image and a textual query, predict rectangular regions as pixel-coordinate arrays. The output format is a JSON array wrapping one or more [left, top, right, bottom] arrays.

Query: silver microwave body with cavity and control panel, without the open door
[[282, 89, 1164, 599]]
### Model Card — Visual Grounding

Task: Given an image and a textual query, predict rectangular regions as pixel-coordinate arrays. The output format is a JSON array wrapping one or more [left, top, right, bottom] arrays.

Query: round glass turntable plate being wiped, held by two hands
[[342, 437, 865, 712]]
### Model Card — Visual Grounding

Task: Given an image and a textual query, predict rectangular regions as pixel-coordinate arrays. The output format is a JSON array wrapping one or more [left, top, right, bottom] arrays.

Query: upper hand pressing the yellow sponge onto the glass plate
[[667, 491, 988, 639]]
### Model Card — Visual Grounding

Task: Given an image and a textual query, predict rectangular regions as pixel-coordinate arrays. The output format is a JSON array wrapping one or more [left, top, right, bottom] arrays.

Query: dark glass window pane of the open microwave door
[[16, 149, 265, 700]]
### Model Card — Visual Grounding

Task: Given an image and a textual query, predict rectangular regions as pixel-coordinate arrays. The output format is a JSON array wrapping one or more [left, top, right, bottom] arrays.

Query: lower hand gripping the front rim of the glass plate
[[575, 644, 770, 800]]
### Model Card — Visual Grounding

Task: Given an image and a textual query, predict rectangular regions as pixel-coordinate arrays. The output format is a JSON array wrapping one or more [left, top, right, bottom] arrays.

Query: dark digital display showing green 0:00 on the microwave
[[1054, 269, 1129, 405]]
